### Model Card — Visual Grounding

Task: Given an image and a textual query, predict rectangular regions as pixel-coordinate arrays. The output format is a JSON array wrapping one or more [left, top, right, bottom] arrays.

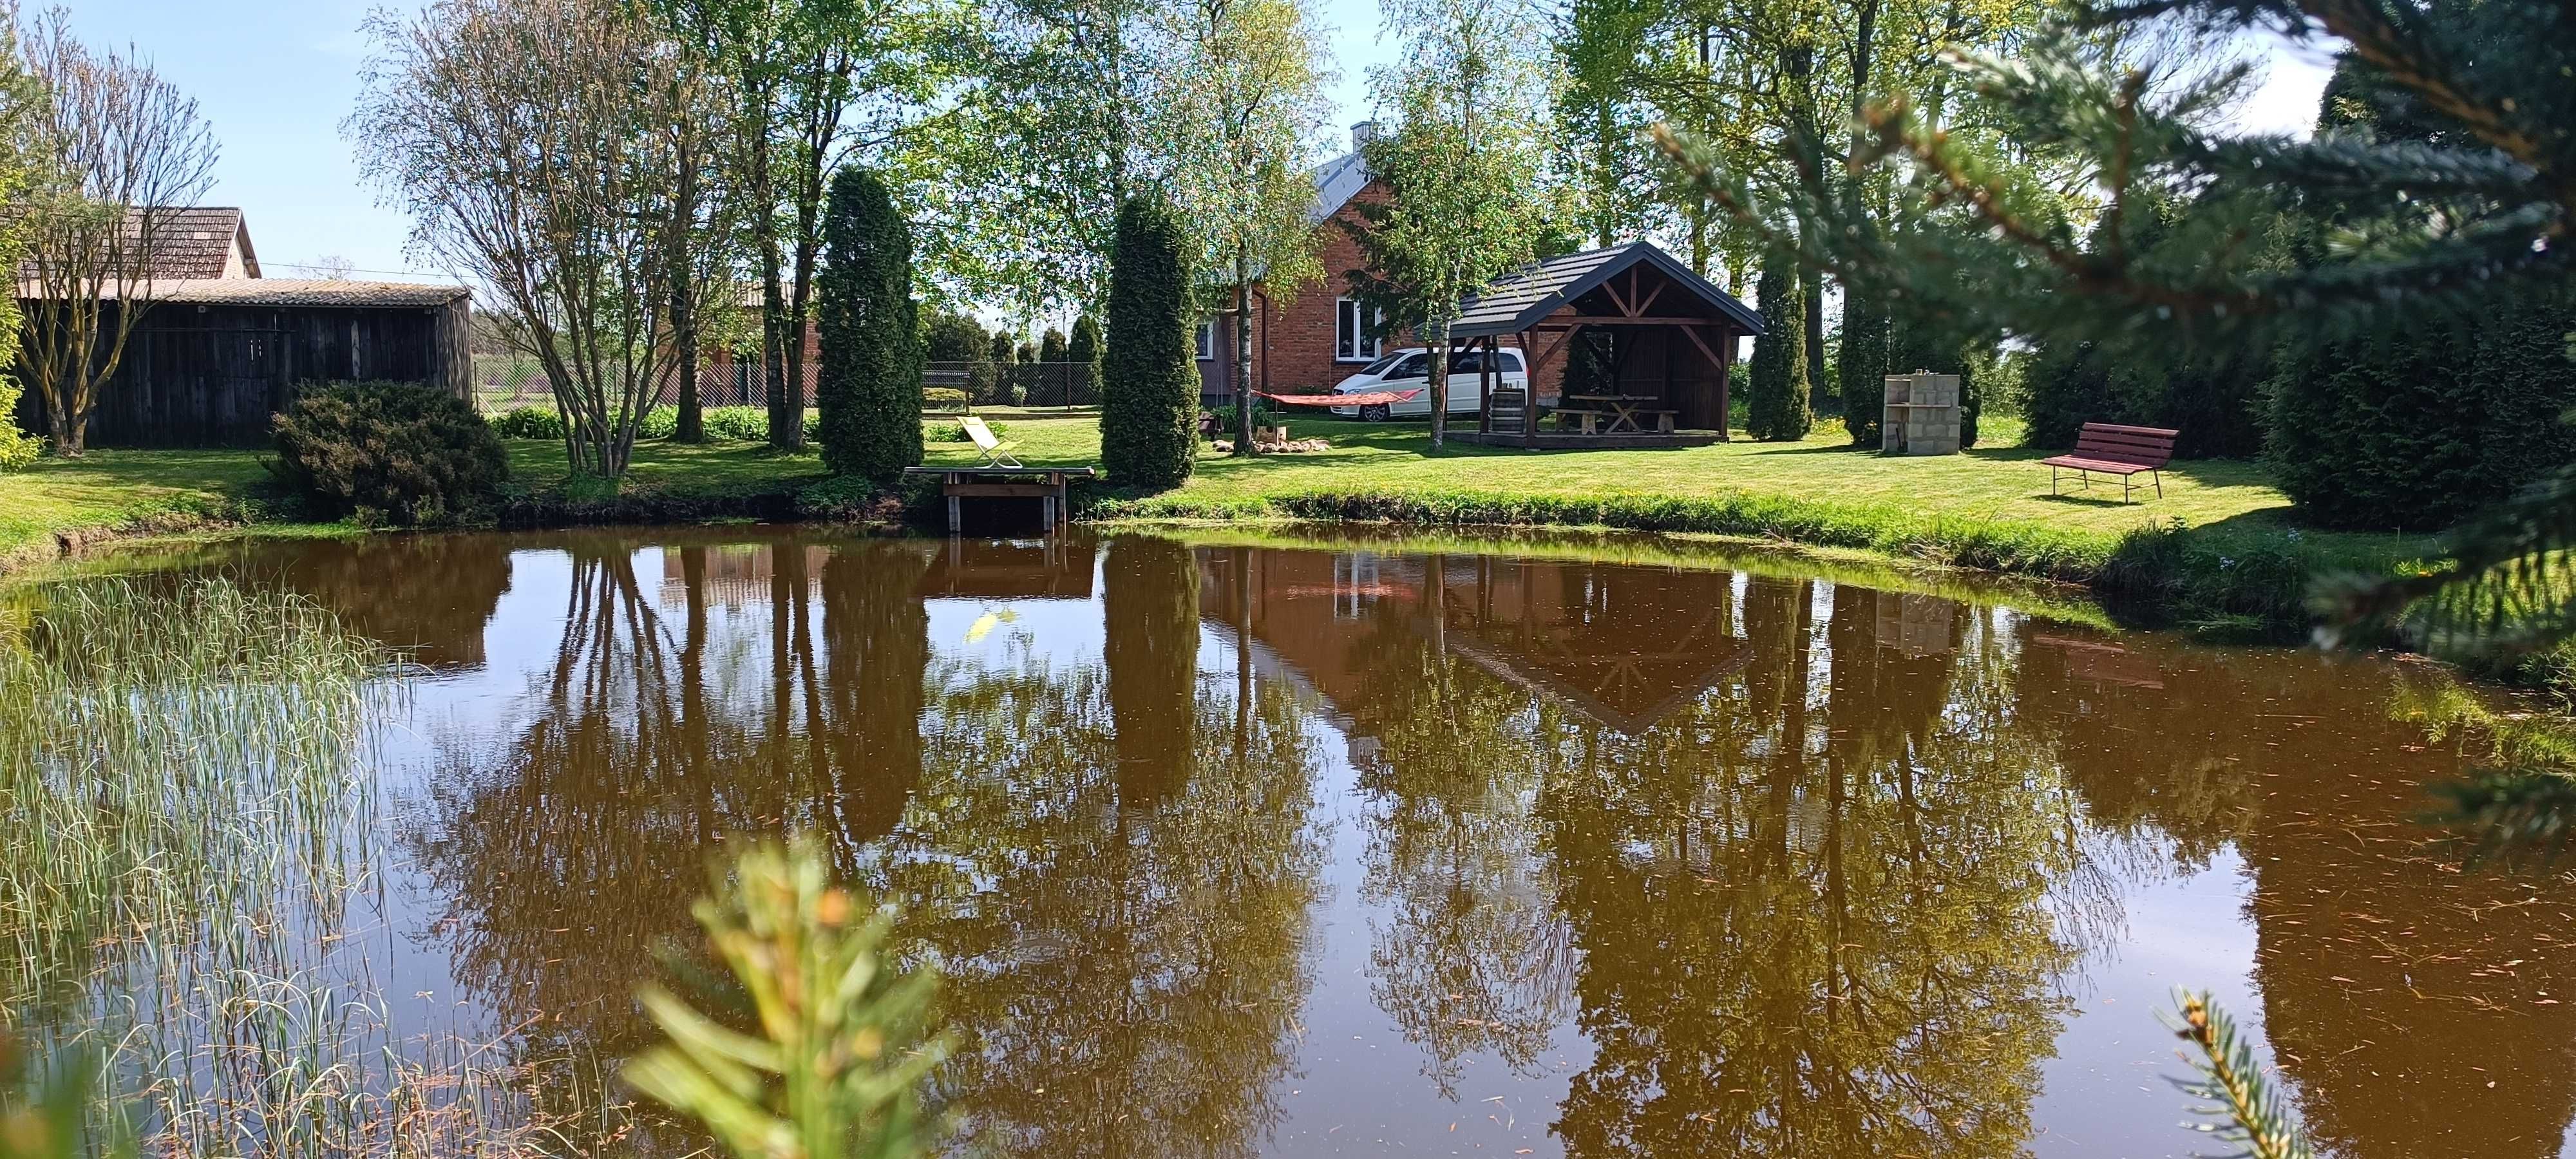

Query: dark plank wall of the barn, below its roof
[[18, 301, 471, 446]]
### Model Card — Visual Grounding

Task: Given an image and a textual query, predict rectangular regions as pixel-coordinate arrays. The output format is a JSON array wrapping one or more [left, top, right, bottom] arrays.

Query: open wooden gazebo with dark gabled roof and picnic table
[[1450, 242, 1762, 448]]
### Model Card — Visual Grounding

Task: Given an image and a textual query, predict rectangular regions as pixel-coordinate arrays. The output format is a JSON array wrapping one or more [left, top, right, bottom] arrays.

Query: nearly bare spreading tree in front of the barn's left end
[[10, 8, 219, 458]]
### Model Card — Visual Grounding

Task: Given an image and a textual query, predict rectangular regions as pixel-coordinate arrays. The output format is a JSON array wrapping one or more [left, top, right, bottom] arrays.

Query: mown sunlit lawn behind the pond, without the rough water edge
[[0, 415, 2318, 556]]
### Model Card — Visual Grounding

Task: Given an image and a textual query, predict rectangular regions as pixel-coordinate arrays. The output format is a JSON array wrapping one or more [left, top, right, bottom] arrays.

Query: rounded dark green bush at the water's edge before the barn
[[270, 381, 510, 525]]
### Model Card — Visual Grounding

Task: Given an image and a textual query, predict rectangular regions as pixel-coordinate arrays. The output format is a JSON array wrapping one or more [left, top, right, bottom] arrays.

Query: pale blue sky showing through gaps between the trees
[[55, 0, 2324, 278]]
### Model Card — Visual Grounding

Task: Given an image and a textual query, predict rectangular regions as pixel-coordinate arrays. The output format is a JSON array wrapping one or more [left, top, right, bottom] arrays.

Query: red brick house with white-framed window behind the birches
[[1198, 121, 1561, 407]]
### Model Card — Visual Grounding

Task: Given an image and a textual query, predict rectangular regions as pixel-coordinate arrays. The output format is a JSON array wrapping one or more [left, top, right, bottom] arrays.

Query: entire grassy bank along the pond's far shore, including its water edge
[[0, 412, 2432, 634]]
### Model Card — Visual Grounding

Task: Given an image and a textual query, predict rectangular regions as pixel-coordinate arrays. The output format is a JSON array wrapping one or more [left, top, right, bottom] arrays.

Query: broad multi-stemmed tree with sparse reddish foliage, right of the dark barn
[[348, 0, 708, 479]]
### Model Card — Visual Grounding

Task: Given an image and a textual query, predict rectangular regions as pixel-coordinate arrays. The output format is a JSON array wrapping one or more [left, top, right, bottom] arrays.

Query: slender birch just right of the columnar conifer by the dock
[[1170, 0, 1332, 456]]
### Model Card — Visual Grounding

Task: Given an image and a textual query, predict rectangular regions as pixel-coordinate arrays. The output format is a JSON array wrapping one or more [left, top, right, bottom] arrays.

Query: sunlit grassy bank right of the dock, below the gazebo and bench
[[1012, 422, 2434, 636]]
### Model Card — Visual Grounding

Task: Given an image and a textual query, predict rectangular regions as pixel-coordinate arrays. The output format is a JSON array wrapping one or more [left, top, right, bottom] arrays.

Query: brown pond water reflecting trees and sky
[[5, 528, 2576, 1156]]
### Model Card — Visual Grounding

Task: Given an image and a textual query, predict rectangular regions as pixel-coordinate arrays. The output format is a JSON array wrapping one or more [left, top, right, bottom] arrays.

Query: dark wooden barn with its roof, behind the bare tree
[[18, 209, 474, 446]]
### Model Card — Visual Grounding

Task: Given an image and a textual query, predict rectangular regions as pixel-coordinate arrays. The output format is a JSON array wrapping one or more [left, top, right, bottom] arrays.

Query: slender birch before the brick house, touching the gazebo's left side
[[1358, 0, 1556, 451]]
